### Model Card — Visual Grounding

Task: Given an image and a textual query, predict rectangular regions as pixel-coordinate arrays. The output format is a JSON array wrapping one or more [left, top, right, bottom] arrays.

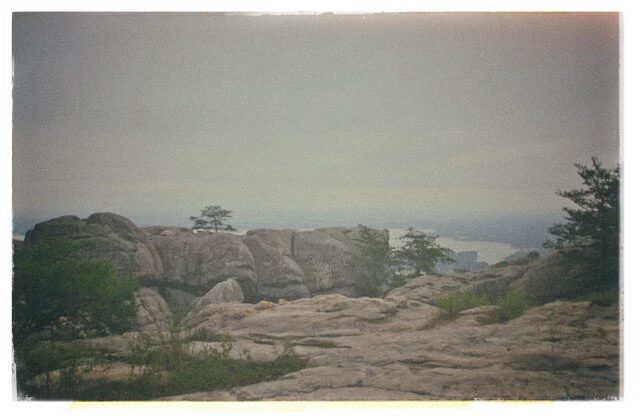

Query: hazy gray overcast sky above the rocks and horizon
[[13, 13, 619, 234]]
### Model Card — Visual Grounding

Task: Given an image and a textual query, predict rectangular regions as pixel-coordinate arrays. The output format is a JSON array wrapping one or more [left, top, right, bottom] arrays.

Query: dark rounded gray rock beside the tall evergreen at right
[[511, 252, 582, 304]]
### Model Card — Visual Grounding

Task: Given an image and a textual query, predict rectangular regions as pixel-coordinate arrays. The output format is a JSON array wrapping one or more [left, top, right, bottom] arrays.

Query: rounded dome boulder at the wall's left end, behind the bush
[[25, 213, 162, 278]]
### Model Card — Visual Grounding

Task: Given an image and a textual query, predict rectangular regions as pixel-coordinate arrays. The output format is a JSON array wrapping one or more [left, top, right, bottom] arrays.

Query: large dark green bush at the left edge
[[12, 239, 138, 347]]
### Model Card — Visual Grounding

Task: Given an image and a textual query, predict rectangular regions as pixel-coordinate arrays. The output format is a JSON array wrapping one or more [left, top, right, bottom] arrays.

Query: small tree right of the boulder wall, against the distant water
[[396, 228, 455, 276]]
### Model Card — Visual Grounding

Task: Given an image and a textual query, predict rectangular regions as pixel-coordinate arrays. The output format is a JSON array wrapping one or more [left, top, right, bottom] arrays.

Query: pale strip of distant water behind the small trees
[[389, 228, 520, 264]]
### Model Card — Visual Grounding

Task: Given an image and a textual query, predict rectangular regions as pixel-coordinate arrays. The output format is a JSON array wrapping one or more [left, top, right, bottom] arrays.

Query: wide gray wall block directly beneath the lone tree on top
[[143, 227, 257, 297]]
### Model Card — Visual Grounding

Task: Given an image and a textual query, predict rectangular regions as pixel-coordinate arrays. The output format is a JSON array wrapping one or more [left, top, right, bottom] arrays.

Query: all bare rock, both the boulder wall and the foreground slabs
[[20, 214, 620, 400]]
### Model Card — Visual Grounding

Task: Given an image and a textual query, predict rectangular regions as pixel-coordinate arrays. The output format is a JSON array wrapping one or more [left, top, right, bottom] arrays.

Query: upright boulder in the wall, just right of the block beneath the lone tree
[[243, 230, 310, 300]]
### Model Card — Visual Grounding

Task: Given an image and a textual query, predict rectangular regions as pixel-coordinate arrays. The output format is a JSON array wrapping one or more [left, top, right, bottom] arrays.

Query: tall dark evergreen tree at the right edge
[[545, 157, 620, 290]]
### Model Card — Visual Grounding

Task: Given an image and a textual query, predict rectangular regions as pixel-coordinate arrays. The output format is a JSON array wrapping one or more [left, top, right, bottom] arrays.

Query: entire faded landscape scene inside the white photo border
[[12, 13, 622, 401]]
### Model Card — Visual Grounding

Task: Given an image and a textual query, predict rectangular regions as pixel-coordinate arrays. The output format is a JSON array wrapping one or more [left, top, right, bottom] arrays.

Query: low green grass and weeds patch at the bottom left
[[21, 330, 306, 400]]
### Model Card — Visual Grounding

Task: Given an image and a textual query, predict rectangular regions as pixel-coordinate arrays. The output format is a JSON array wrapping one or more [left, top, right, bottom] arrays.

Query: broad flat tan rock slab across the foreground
[[169, 295, 620, 400]]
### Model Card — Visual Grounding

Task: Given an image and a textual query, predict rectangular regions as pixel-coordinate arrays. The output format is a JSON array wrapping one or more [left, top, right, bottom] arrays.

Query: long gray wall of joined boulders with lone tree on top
[[24, 213, 389, 319]]
